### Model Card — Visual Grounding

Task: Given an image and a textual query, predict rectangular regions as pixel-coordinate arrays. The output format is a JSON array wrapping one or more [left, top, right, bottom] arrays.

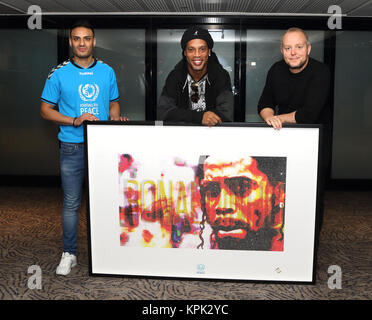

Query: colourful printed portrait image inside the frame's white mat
[[118, 154, 286, 251]]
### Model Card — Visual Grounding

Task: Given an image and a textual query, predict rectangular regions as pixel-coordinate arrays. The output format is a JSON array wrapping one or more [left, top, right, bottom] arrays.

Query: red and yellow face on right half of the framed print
[[198, 156, 285, 251]]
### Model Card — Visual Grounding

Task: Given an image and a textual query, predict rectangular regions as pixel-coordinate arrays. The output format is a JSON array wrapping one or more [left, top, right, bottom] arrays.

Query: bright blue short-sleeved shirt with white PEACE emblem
[[41, 59, 119, 143]]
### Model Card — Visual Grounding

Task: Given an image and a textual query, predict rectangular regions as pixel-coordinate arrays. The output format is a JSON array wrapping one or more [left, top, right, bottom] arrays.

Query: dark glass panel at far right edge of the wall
[[332, 31, 372, 179]]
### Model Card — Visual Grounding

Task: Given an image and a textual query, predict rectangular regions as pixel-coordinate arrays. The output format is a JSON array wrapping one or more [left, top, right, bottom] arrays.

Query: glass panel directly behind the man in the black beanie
[[157, 29, 235, 109]]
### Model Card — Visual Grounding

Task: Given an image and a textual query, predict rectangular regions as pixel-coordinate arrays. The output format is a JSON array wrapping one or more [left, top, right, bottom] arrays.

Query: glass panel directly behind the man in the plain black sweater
[[245, 30, 324, 122]]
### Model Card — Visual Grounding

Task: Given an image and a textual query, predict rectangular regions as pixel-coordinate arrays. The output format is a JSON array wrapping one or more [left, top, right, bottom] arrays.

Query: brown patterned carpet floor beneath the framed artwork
[[0, 187, 372, 300]]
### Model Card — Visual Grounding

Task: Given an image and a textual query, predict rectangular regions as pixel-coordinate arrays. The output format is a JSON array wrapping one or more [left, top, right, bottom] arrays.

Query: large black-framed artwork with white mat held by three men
[[85, 122, 320, 282]]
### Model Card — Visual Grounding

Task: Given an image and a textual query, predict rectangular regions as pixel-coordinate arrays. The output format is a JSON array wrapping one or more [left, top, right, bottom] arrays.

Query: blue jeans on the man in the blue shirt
[[59, 142, 85, 255]]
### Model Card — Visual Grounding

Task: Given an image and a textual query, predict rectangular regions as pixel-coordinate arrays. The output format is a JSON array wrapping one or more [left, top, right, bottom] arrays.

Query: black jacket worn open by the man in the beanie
[[157, 52, 234, 124]]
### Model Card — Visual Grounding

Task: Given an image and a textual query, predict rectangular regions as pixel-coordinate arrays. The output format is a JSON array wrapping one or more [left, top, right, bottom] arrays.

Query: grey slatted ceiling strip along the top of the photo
[[0, 0, 372, 17]]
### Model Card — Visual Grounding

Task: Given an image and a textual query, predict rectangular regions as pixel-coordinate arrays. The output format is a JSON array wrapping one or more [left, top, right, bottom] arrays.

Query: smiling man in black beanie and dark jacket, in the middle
[[157, 27, 234, 126]]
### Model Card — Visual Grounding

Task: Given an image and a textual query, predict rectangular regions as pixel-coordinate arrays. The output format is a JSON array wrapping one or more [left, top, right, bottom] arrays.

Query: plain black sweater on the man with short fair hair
[[258, 58, 331, 127]]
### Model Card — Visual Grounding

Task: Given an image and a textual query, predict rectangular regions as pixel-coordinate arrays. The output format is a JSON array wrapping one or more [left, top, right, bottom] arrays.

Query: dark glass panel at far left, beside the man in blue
[[0, 29, 58, 175]]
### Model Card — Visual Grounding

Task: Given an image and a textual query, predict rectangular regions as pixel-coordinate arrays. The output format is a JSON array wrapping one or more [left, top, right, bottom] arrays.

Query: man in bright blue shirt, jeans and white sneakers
[[40, 21, 128, 275]]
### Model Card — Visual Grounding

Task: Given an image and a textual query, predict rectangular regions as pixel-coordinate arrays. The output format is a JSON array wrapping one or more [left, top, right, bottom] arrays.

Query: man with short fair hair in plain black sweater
[[258, 28, 331, 235]]
